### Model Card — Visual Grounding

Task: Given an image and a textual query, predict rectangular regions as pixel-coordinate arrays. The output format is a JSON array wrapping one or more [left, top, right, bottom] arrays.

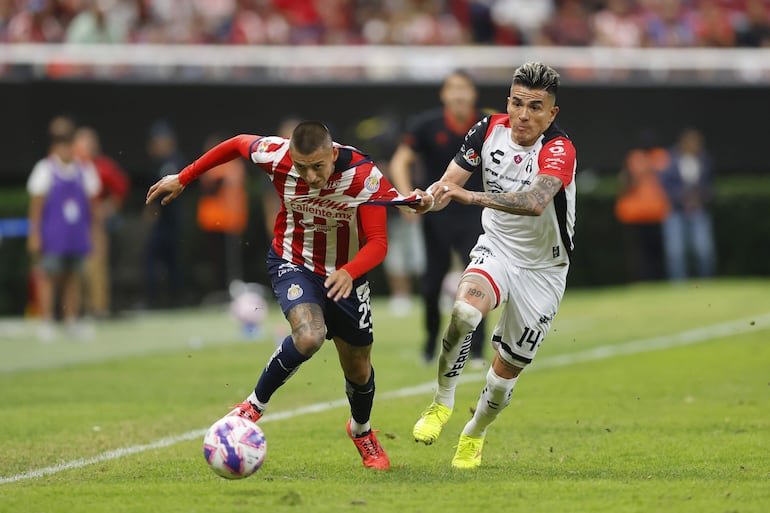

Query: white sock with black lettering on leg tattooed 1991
[[434, 301, 482, 408]]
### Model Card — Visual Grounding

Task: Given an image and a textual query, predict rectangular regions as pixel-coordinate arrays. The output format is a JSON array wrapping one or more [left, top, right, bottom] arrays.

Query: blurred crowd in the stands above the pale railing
[[0, 0, 770, 48]]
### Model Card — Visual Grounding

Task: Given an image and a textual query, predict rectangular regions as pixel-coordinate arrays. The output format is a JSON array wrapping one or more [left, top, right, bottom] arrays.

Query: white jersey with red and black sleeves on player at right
[[454, 114, 577, 269]]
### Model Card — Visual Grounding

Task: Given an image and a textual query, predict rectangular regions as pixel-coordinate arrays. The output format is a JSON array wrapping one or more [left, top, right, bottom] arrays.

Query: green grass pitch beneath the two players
[[0, 280, 770, 513]]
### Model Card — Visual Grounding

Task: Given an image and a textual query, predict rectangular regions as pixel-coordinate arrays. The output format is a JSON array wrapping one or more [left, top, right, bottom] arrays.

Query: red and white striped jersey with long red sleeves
[[179, 134, 405, 279]]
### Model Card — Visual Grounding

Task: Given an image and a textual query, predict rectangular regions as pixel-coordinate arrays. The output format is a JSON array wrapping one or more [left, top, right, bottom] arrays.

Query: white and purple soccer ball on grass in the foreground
[[203, 416, 267, 479]]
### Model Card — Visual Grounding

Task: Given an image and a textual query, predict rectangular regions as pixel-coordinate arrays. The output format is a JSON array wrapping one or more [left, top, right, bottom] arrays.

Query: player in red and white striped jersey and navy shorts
[[147, 121, 429, 469]]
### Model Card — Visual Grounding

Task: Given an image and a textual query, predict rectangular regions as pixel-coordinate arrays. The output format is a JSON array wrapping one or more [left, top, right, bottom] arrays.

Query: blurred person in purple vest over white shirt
[[27, 116, 101, 341]]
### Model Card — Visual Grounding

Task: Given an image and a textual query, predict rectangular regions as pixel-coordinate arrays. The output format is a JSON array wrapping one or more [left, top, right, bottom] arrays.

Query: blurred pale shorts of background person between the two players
[[383, 214, 425, 276]]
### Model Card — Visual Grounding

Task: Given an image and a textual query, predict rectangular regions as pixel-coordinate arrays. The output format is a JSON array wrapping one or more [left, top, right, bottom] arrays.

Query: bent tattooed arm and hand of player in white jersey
[[434, 170, 563, 216]]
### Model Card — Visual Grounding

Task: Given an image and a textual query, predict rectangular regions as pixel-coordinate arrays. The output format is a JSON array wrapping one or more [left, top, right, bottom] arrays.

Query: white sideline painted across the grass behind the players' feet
[[0, 314, 770, 484]]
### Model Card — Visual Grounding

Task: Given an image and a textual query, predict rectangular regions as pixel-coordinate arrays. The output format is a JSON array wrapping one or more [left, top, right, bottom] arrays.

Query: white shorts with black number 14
[[463, 241, 569, 367]]
